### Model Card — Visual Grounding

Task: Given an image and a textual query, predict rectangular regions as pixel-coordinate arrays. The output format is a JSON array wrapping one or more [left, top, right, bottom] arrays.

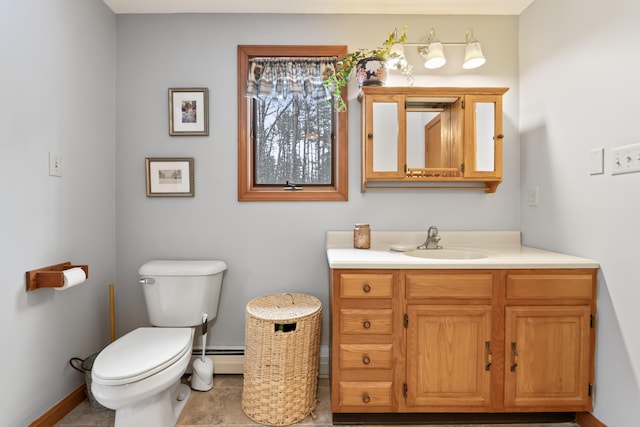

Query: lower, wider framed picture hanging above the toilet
[[145, 157, 195, 197]]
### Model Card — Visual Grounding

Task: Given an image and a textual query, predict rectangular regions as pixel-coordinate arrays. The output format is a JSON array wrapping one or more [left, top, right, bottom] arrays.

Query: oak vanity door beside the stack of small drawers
[[406, 305, 491, 411]]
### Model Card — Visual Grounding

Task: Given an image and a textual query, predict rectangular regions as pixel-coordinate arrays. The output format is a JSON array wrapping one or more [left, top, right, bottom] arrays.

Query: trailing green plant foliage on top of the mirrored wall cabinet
[[324, 24, 413, 111]]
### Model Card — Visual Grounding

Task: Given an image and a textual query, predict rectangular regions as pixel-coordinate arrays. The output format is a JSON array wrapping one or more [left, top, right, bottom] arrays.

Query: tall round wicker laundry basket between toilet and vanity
[[242, 293, 322, 426]]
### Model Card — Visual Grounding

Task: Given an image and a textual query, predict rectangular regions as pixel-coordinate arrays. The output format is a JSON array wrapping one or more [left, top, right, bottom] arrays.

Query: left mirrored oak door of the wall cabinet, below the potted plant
[[362, 95, 407, 179]]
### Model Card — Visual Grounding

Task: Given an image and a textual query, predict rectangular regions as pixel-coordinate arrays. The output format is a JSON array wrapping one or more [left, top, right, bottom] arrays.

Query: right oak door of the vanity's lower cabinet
[[505, 305, 591, 411]]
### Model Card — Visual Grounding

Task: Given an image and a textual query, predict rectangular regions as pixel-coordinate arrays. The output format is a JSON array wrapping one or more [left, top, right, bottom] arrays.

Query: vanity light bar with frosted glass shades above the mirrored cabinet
[[403, 28, 487, 70]]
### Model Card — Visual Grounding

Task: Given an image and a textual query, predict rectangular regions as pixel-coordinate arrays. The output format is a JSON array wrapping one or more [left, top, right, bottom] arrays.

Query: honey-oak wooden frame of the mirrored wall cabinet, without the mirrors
[[359, 86, 508, 193]]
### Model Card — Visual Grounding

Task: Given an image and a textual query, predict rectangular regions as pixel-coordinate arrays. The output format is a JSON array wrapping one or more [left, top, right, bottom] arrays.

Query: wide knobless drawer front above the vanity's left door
[[405, 273, 493, 300]]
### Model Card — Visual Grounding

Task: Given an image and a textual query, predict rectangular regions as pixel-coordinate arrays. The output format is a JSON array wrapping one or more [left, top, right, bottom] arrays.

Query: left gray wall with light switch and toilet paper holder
[[0, 0, 116, 427]]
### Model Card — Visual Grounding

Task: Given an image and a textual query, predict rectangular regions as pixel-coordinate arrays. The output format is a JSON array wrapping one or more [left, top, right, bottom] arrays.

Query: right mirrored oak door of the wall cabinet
[[464, 95, 503, 179]]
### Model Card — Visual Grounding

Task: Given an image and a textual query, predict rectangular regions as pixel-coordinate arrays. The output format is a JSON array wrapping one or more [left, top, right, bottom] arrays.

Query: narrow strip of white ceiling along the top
[[103, 0, 534, 15]]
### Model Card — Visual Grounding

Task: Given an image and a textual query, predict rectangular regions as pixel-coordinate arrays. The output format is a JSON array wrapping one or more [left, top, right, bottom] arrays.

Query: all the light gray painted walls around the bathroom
[[11, 0, 640, 426]]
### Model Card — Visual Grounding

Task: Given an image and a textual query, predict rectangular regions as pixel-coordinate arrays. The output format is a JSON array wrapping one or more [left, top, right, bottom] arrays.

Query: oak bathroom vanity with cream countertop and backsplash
[[327, 231, 599, 418]]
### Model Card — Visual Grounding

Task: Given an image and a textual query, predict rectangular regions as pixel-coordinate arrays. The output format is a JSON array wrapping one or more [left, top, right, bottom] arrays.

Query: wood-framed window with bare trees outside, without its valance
[[238, 46, 348, 201]]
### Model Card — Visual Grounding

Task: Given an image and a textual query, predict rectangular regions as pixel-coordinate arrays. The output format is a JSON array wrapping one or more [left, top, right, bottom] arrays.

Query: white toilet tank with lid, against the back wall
[[138, 260, 227, 327]]
